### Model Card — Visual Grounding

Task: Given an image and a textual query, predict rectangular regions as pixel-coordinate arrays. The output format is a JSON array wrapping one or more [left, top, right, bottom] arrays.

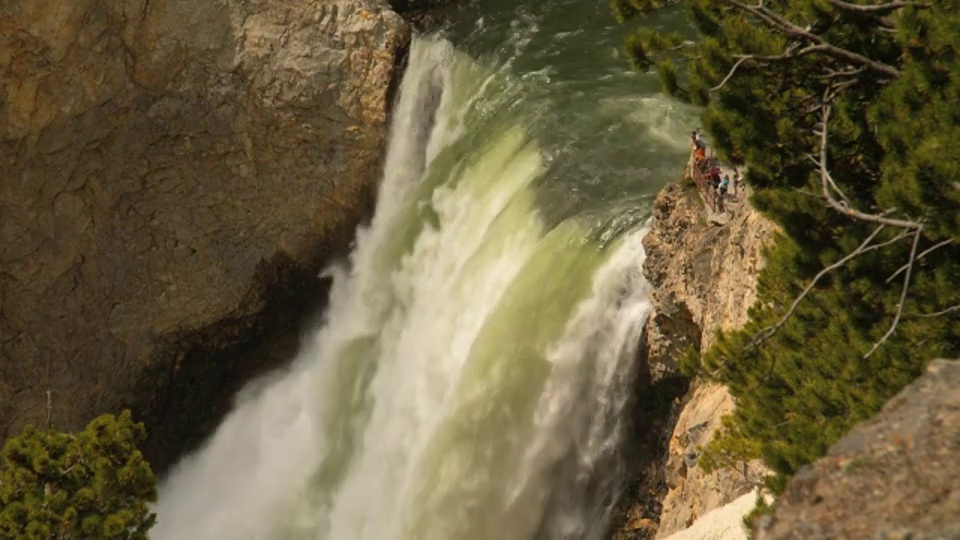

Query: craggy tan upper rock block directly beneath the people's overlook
[[643, 184, 774, 373]]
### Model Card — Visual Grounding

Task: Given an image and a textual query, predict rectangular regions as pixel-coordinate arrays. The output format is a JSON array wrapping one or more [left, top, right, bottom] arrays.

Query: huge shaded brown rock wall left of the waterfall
[[0, 0, 409, 466]]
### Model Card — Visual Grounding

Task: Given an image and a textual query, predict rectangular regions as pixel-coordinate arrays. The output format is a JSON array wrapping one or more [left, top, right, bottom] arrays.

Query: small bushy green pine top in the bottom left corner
[[0, 411, 157, 540]]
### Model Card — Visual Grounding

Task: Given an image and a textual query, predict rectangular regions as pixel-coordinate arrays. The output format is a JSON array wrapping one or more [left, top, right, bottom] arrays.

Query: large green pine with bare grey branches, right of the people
[[626, 0, 960, 492]]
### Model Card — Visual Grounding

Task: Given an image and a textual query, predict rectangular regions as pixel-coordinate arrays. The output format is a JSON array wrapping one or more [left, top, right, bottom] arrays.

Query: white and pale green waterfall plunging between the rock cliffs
[[152, 2, 692, 540]]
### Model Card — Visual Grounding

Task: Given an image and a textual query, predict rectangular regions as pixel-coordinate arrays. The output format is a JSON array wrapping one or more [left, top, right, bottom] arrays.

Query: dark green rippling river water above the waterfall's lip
[[442, 0, 698, 227]]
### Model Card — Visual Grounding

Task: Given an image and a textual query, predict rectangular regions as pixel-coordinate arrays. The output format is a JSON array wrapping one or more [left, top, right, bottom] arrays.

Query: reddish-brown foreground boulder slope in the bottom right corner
[[755, 360, 960, 540]]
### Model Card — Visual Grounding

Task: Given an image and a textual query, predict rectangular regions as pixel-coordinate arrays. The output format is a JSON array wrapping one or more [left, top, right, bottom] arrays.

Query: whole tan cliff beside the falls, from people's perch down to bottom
[[618, 167, 774, 538]]
